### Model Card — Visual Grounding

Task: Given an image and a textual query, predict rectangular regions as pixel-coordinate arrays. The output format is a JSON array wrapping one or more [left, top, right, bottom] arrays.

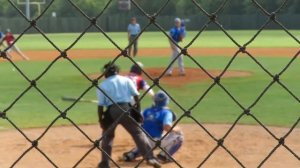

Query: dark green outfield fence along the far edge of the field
[[0, 13, 300, 34]]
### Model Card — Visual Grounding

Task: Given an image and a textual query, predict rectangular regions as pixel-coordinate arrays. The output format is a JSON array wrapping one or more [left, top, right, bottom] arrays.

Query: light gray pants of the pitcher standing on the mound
[[167, 43, 185, 74]]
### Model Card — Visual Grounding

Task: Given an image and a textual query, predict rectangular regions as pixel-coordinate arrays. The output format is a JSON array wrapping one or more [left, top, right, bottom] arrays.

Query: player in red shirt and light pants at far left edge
[[0, 29, 29, 60]]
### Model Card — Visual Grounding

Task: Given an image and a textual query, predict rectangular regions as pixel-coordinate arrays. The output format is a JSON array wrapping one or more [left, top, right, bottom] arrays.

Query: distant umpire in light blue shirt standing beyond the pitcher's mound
[[127, 17, 141, 57]]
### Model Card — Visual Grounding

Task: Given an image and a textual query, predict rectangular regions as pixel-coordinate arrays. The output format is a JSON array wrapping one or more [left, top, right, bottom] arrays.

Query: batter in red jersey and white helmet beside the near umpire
[[127, 62, 154, 97]]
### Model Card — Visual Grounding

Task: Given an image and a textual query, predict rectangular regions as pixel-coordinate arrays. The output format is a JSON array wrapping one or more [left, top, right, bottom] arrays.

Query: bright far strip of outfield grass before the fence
[[14, 30, 300, 50]]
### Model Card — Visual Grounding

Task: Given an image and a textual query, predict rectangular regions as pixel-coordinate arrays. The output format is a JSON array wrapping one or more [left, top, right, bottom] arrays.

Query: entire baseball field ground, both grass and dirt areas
[[0, 30, 300, 168]]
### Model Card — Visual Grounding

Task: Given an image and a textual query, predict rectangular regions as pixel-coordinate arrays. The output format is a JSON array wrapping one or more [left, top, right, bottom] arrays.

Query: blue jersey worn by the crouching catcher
[[142, 106, 173, 138]]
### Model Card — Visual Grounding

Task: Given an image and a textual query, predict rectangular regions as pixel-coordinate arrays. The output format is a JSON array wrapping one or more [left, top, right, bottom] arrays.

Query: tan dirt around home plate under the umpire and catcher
[[0, 124, 300, 168]]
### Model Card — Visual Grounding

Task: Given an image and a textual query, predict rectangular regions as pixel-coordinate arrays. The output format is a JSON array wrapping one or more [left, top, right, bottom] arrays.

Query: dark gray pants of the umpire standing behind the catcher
[[101, 104, 153, 162]]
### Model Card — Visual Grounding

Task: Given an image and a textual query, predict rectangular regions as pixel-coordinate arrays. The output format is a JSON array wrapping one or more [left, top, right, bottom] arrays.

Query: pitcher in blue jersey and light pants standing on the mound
[[167, 18, 186, 76]]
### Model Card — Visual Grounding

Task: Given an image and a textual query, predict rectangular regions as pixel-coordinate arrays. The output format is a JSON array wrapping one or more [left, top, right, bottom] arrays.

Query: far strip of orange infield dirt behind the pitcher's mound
[[0, 48, 299, 61]]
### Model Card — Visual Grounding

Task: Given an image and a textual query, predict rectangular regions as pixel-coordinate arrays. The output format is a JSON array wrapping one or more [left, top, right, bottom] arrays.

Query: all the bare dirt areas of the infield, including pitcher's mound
[[0, 48, 300, 168]]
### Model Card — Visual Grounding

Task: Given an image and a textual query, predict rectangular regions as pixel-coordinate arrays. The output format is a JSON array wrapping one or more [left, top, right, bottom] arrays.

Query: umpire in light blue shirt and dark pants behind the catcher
[[97, 63, 160, 168]]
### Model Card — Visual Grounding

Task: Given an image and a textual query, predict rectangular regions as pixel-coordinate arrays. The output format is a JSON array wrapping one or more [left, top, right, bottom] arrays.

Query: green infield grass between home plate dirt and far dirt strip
[[0, 56, 300, 128]]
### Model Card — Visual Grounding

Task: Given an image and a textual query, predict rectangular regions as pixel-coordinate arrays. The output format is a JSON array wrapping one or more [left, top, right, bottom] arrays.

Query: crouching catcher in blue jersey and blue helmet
[[122, 91, 183, 163]]
